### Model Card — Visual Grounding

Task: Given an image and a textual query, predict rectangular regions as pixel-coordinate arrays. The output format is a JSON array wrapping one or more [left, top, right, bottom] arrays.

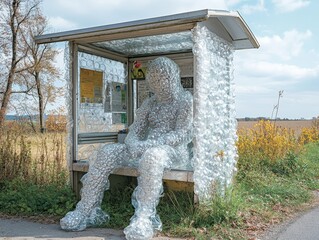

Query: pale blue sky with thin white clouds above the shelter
[[42, 0, 319, 119]]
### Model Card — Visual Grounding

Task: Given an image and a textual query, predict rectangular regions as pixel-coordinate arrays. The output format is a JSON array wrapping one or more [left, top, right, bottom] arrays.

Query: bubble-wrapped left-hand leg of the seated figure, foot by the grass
[[60, 144, 127, 231]]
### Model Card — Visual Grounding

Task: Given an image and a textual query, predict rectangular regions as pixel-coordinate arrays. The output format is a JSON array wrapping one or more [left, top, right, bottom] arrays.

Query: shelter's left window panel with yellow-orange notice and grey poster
[[78, 52, 127, 133]]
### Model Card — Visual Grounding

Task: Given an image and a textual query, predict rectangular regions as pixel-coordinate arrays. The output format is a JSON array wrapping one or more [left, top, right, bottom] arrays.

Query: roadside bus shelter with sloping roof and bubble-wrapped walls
[[35, 9, 259, 201]]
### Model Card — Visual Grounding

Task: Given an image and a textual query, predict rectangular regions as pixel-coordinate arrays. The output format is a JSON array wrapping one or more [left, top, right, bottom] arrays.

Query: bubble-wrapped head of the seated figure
[[146, 57, 182, 98]]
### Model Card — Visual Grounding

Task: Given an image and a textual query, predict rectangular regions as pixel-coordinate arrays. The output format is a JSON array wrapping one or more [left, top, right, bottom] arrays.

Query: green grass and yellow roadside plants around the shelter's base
[[0, 117, 319, 239]]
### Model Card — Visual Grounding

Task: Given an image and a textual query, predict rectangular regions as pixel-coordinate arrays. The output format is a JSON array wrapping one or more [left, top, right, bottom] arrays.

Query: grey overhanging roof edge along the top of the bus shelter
[[35, 9, 259, 49]]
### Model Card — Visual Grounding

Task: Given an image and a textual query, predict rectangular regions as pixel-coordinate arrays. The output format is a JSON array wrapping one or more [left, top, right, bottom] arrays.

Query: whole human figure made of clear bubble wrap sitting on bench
[[60, 57, 193, 240]]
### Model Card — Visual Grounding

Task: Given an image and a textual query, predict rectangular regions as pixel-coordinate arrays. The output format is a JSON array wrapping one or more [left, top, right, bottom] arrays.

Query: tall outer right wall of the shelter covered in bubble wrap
[[193, 24, 237, 202]]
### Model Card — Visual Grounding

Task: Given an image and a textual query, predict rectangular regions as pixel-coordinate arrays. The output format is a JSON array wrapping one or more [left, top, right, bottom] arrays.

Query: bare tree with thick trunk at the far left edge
[[0, 0, 40, 128]]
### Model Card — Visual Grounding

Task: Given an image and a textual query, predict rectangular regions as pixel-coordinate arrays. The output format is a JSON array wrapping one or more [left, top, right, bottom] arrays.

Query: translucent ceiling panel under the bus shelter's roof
[[93, 31, 193, 56]]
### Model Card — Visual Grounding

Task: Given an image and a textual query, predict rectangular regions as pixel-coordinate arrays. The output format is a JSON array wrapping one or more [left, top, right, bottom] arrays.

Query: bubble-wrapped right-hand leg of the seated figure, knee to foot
[[124, 146, 175, 240]]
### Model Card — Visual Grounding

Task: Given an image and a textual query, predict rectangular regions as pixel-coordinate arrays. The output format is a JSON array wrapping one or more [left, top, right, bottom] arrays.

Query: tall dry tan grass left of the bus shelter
[[0, 130, 68, 184]]
